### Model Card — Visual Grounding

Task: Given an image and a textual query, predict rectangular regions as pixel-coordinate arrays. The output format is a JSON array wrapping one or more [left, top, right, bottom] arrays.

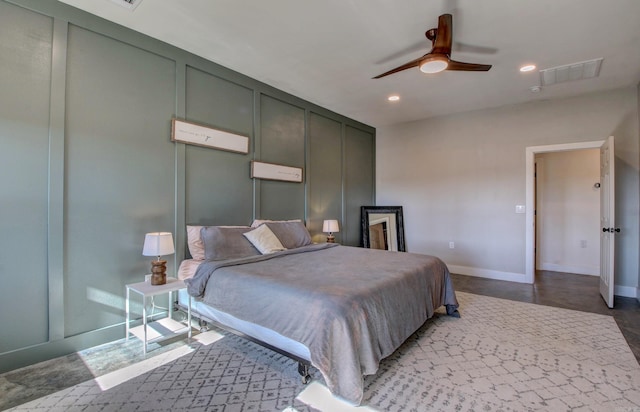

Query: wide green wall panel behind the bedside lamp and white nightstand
[[65, 25, 175, 336]]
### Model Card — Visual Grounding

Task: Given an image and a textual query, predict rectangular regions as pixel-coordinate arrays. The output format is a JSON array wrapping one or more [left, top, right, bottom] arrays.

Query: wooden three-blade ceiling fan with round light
[[374, 14, 491, 79]]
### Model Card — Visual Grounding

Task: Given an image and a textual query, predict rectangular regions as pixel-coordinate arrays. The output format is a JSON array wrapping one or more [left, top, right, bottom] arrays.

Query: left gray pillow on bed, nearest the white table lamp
[[200, 226, 260, 260]]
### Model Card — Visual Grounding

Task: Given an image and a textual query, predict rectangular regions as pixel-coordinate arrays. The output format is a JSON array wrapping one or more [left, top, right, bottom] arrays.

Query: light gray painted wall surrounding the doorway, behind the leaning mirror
[[376, 87, 640, 296]]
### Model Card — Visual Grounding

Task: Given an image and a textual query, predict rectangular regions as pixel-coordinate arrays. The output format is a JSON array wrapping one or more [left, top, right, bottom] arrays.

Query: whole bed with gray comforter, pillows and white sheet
[[179, 221, 459, 405]]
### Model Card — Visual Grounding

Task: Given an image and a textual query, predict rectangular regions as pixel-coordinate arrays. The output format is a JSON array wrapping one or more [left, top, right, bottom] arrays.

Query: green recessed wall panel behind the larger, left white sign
[[185, 67, 254, 229]]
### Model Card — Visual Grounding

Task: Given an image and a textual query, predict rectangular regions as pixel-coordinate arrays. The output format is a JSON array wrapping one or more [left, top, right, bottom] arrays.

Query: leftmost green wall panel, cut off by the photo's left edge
[[0, 3, 53, 353]]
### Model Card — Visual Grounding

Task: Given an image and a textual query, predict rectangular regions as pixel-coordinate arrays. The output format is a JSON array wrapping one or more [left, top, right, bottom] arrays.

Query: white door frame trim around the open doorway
[[525, 140, 605, 283]]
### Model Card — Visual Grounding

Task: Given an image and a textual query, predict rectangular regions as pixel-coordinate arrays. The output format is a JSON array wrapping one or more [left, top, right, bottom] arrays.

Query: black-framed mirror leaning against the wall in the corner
[[360, 206, 407, 252]]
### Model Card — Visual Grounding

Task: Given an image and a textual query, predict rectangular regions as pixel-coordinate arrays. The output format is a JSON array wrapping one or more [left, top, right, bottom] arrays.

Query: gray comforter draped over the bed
[[187, 244, 458, 404]]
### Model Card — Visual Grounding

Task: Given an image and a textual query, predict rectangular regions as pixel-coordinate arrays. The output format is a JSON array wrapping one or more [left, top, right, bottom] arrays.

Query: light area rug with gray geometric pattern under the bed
[[6, 292, 640, 412]]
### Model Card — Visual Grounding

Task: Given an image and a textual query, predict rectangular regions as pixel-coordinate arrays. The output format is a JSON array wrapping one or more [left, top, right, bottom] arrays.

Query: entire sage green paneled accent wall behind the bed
[[0, 0, 375, 372]]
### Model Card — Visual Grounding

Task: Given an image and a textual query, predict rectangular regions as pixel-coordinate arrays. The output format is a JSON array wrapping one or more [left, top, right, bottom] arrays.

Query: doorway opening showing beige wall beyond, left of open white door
[[534, 149, 600, 276]]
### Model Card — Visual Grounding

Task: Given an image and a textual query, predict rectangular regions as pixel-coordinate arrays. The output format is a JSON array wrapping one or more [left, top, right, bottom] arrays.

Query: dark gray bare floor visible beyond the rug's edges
[[0, 272, 640, 410]]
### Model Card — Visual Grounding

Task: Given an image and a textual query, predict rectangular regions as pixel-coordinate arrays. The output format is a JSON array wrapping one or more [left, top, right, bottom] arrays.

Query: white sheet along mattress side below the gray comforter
[[178, 259, 311, 361]]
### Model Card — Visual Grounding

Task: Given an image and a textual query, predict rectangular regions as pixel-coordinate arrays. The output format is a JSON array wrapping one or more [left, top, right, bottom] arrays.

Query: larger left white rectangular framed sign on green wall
[[171, 118, 249, 154]]
